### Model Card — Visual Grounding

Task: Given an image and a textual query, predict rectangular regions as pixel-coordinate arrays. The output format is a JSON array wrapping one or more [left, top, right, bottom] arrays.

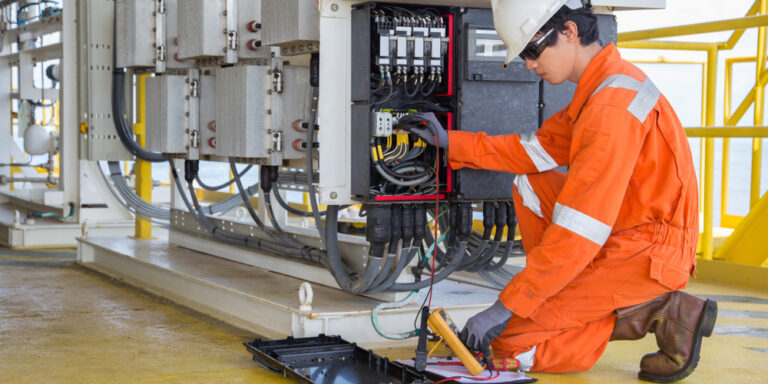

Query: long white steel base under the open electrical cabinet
[[78, 236, 499, 348]]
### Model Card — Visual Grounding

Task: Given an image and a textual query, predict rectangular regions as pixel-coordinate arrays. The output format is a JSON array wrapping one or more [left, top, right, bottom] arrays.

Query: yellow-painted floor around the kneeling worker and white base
[[0, 249, 768, 384]]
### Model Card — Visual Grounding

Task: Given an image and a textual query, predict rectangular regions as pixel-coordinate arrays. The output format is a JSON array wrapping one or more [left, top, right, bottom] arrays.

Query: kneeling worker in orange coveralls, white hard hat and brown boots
[[400, 0, 717, 382]]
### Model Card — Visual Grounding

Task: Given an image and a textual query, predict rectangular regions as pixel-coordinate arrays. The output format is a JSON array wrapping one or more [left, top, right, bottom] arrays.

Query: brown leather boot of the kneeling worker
[[611, 291, 717, 383]]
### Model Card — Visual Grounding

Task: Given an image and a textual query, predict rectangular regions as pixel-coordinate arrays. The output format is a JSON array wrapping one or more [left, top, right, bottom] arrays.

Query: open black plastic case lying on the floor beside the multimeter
[[243, 335, 442, 384]]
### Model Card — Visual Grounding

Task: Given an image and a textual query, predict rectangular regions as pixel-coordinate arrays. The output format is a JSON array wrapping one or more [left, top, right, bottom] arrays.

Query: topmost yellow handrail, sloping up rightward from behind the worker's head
[[618, 14, 768, 42]]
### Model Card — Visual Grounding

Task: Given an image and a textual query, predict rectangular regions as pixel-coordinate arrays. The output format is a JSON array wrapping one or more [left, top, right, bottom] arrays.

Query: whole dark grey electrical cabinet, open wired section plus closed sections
[[351, 3, 616, 202]]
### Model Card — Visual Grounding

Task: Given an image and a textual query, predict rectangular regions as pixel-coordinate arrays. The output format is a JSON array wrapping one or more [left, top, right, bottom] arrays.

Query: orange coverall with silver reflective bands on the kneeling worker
[[448, 44, 699, 372]]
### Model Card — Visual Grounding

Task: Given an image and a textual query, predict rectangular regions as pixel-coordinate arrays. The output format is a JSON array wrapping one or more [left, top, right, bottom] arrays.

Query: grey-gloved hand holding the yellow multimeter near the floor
[[459, 300, 512, 356]]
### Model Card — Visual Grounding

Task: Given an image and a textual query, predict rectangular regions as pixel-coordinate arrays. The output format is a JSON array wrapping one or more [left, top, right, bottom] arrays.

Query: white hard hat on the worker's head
[[491, 0, 583, 64]]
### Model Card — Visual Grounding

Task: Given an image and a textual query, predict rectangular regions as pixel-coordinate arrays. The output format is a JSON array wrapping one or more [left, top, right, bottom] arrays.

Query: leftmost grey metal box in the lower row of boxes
[[146, 75, 188, 154]]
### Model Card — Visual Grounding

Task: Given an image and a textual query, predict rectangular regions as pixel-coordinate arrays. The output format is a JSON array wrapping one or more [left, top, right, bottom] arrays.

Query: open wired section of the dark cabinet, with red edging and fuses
[[352, 3, 456, 202]]
